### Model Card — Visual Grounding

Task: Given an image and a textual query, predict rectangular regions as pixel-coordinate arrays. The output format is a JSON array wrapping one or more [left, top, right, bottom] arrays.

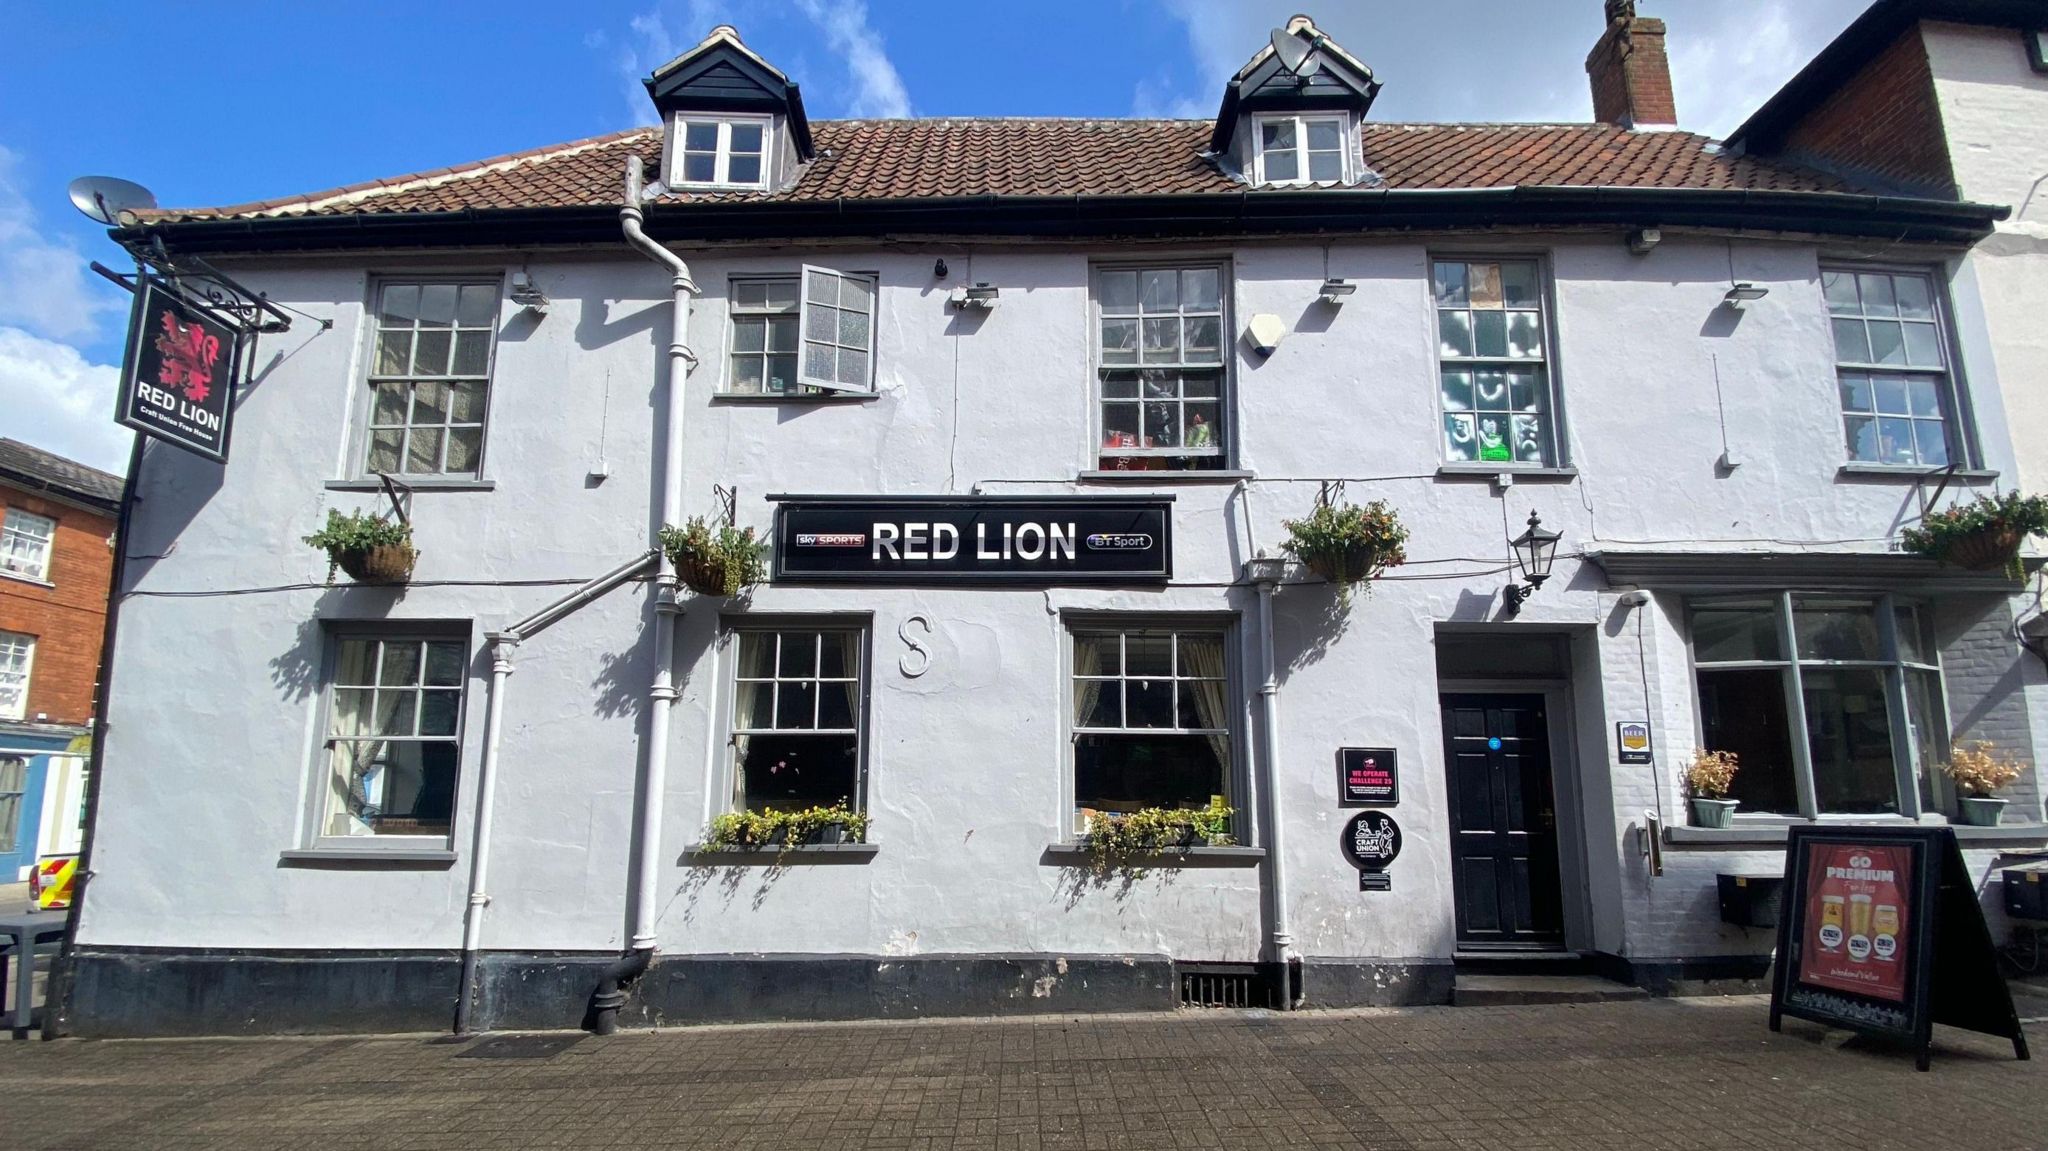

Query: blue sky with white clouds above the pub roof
[[0, 0, 1864, 469]]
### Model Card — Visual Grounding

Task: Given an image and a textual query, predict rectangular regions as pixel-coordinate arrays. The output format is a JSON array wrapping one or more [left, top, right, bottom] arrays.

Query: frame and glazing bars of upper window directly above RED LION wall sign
[[1087, 258, 1237, 475]]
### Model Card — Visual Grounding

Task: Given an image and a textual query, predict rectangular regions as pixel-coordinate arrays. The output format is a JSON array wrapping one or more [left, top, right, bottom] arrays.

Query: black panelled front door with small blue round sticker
[[1442, 694, 1565, 948]]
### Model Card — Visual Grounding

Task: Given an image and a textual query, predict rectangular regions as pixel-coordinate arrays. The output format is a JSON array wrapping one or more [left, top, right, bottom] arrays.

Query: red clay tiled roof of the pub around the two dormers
[[147, 119, 1855, 221]]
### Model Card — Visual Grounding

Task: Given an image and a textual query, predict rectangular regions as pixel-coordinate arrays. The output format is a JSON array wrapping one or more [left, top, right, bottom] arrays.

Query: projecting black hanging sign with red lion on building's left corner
[[115, 279, 242, 463]]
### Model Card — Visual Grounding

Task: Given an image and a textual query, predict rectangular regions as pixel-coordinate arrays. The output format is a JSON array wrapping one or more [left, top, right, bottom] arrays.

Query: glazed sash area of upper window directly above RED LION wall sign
[[1096, 264, 1227, 471]]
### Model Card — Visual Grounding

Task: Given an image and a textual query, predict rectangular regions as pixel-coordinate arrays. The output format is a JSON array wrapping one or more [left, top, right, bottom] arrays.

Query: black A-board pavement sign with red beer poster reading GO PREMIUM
[[1772, 827, 2028, 1071]]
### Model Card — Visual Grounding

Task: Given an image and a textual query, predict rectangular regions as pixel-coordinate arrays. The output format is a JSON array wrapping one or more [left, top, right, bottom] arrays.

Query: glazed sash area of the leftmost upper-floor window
[[362, 281, 498, 477]]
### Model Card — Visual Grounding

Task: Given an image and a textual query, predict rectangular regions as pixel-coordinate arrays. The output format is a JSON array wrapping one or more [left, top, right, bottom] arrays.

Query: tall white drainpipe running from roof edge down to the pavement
[[590, 156, 696, 1034]]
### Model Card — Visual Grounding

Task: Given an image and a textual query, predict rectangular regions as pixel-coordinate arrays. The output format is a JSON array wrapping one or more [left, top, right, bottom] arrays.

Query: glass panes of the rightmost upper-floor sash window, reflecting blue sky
[[1821, 268, 1962, 467]]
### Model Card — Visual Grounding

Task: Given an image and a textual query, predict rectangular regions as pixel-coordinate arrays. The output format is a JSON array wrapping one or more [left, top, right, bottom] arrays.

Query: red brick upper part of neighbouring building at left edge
[[0, 440, 121, 725]]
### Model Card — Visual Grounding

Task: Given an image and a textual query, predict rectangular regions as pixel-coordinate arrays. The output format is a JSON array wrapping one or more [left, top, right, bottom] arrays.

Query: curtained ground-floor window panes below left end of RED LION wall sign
[[731, 629, 866, 811]]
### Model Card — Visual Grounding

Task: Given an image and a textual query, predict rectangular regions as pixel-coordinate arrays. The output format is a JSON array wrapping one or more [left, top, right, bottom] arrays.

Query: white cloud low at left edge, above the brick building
[[0, 326, 133, 475]]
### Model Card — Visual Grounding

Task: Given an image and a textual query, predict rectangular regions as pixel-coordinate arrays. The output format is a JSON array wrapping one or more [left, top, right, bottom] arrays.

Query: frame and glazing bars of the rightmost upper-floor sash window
[[1821, 262, 1976, 471]]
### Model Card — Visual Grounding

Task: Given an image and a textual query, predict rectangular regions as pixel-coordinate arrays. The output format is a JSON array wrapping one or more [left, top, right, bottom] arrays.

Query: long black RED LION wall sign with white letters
[[774, 496, 1174, 584]]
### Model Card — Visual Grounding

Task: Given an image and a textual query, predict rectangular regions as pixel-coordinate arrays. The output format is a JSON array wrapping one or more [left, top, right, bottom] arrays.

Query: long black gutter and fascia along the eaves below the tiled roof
[[113, 184, 2011, 251]]
